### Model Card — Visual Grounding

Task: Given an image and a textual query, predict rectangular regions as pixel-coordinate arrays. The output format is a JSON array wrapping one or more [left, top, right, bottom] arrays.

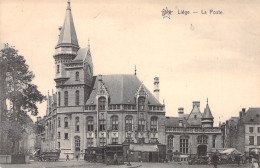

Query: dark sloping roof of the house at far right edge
[[243, 108, 260, 124]]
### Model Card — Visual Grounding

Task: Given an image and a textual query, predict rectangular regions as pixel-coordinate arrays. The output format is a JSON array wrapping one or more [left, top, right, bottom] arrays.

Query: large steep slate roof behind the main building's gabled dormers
[[86, 75, 162, 106]]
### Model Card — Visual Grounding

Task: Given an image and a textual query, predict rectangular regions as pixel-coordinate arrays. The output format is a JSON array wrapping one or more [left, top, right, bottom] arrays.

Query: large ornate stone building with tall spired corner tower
[[41, 2, 165, 158]]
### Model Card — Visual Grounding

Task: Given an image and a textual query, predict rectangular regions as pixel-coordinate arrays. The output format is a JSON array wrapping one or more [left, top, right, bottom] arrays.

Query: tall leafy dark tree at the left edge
[[0, 45, 46, 154]]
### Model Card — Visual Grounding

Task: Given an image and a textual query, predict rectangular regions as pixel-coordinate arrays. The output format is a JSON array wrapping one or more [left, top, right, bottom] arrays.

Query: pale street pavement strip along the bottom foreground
[[0, 160, 251, 168]]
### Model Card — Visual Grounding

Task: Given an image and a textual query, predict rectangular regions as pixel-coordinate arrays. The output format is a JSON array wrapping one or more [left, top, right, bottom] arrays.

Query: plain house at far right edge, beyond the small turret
[[225, 108, 260, 154]]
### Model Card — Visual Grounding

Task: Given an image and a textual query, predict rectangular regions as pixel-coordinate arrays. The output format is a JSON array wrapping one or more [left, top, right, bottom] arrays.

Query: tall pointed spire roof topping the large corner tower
[[56, 1, 79, 48]]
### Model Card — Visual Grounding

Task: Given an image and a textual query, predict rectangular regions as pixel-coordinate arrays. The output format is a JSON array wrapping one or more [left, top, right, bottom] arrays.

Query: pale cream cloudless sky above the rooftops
[[0, 0, 260, 125]]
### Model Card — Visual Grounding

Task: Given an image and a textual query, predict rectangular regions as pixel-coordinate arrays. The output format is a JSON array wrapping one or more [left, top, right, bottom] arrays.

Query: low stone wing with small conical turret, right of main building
[[165, 101, 223, 161]]
